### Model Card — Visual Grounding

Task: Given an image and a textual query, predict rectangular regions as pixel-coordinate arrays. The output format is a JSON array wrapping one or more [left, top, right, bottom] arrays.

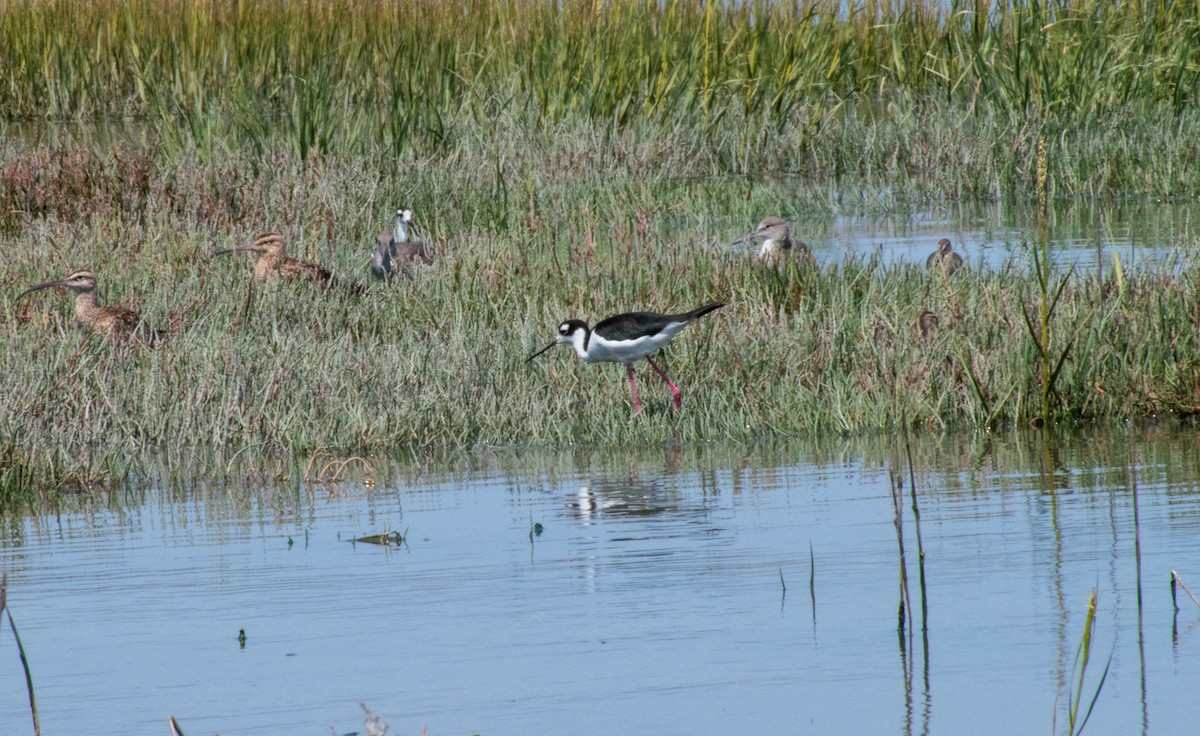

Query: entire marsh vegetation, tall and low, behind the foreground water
[[0, 0, 1200, 487]]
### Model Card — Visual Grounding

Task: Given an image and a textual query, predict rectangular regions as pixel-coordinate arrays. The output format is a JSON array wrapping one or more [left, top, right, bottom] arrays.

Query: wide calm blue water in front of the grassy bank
[[0, 429, 1200, 734]]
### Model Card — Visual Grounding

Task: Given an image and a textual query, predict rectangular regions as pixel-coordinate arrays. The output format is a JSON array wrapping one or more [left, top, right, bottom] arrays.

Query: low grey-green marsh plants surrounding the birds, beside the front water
[[0, 143, 1200, 494]]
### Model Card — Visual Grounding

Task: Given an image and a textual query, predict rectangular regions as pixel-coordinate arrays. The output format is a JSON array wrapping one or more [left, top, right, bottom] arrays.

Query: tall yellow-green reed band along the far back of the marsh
[[0, 0, 1200, 123]]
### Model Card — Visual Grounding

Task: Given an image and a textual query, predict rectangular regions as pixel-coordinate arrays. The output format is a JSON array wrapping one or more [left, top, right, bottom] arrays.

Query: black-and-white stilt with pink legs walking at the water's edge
[[527, 303, 725, 414]]
